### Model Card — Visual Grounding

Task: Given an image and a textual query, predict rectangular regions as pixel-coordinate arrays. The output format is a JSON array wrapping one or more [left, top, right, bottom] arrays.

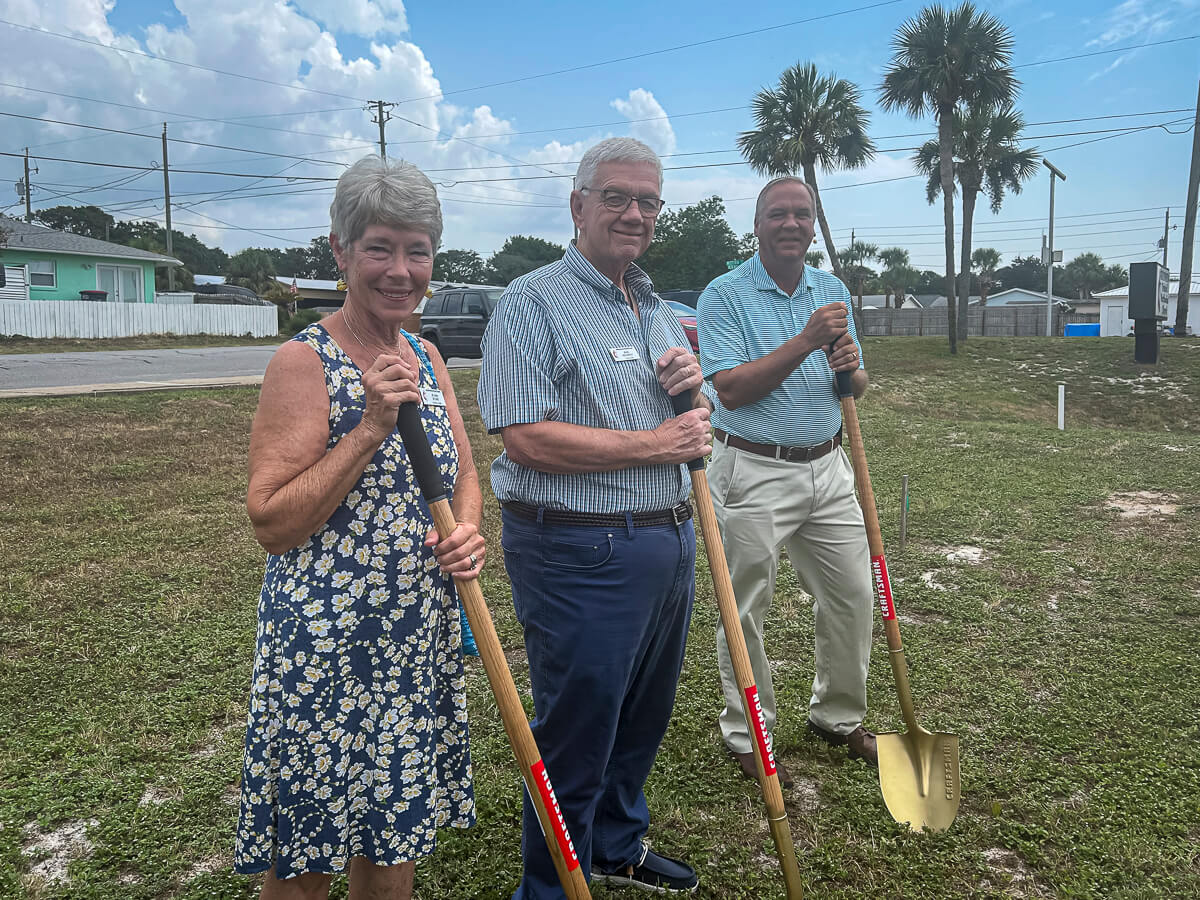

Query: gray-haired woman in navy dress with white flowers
[[234, 156, 485, 900]]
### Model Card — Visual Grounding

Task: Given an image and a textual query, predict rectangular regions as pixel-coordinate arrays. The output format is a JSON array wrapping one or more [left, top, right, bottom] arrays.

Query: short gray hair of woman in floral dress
[[329, 154, 442, 251]]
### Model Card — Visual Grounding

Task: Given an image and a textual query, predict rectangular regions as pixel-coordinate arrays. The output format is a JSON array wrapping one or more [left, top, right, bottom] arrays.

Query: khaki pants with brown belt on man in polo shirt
[[708, 443, 874, 752]]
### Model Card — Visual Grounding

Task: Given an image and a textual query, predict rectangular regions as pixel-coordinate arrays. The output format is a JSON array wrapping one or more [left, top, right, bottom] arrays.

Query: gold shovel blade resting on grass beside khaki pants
[[876, 728, 960, 832]]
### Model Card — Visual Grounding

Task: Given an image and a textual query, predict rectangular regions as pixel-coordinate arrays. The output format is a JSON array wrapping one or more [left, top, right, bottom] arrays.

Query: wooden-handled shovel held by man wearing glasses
[[671, 392, 804, 900]]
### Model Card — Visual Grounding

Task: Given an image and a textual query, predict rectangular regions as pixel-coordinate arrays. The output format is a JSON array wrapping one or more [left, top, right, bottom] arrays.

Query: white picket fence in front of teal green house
[[0, 300, 280, 337]]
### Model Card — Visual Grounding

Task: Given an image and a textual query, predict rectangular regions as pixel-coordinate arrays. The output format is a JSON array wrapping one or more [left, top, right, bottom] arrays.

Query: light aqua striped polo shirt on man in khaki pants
[[696, 253, 863, 446]]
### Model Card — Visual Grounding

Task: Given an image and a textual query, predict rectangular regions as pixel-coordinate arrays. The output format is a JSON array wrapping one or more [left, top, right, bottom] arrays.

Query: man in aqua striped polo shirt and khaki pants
[[697, 178, 876, 786]]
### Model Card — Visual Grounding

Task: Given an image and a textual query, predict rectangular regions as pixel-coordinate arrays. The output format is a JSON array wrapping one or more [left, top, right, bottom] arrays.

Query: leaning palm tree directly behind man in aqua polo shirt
[[738, 62, 875, 278]]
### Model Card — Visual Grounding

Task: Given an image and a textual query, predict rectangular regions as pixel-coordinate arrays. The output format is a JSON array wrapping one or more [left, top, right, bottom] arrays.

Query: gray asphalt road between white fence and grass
[[0, 347, 479, 397]]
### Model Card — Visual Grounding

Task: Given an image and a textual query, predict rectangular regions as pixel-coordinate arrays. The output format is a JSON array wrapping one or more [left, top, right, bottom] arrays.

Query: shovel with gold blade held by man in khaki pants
[[836, 372, 960, 832]]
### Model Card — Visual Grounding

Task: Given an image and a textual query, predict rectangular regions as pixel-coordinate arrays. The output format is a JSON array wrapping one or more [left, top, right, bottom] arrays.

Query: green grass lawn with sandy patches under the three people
[[0, 337, 1200, 900]]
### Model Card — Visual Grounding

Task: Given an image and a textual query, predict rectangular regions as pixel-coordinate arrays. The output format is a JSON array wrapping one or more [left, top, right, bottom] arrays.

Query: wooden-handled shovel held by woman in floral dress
[[396, 403, 592, 900]]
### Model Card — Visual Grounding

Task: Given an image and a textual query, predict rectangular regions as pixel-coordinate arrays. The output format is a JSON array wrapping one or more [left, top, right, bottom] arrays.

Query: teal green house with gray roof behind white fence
[[0, 216, 182, 304]]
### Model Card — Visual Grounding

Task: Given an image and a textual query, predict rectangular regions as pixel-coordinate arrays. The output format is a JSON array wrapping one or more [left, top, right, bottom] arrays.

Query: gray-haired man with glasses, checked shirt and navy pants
[[479, 138, 712, 900]]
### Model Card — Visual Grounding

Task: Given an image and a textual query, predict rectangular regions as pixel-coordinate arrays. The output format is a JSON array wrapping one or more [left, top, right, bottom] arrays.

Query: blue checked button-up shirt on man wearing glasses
[[479, 244, 691, 512]]
